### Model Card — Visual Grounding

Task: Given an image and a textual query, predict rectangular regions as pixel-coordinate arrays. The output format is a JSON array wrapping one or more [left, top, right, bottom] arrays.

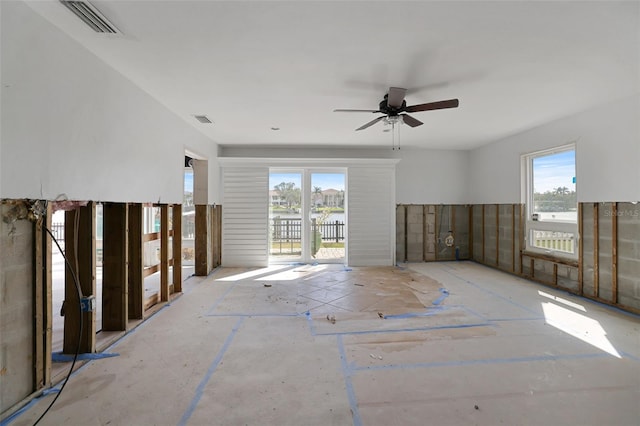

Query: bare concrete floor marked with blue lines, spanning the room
[[10, 262, 640, 426]]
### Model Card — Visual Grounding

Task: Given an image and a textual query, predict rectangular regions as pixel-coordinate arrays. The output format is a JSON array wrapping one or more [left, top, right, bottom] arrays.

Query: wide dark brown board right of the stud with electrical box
[[102, 203, 129, 331]]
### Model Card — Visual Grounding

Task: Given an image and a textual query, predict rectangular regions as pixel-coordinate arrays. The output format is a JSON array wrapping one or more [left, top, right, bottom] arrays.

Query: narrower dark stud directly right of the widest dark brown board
[[127, 203, 144, 319]]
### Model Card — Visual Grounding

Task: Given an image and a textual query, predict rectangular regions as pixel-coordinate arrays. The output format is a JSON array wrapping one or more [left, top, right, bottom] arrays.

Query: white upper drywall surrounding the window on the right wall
[[469, 94, 640, 203]]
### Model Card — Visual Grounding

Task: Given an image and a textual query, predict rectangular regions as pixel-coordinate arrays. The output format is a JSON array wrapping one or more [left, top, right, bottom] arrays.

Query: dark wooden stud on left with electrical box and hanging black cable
[[62, 202, 96, 354]]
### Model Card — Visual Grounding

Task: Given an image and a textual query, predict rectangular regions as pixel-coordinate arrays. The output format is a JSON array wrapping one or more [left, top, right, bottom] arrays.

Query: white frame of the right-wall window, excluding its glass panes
[[521, 142, 580, 260]]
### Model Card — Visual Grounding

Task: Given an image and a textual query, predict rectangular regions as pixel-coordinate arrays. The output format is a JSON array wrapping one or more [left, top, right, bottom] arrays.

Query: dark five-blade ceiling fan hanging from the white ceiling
[[333, 87, 459, 131]]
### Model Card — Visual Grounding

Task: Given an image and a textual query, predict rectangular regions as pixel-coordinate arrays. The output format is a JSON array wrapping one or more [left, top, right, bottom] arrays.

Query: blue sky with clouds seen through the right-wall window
[[533, 150, 576, 194]]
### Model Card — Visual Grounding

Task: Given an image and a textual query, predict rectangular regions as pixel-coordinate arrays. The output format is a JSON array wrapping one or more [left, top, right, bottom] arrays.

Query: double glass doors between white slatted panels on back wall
[[269, 168, 347, 263]]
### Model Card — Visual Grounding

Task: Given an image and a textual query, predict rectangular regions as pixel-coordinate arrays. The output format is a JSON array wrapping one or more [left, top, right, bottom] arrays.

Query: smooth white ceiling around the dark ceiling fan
[[22, 0, 640, 149]]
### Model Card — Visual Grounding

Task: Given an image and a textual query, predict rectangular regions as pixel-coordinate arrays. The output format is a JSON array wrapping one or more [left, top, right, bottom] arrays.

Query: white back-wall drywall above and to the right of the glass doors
[[221, 146, 469, 204]]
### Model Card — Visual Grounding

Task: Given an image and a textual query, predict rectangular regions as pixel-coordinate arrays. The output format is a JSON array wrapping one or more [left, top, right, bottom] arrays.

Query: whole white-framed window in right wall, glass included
[[522, 144, 578, 257]]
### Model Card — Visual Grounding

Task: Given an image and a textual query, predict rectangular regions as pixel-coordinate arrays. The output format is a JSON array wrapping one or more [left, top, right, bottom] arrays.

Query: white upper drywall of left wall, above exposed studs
[[0, 2, 218, 203]]
